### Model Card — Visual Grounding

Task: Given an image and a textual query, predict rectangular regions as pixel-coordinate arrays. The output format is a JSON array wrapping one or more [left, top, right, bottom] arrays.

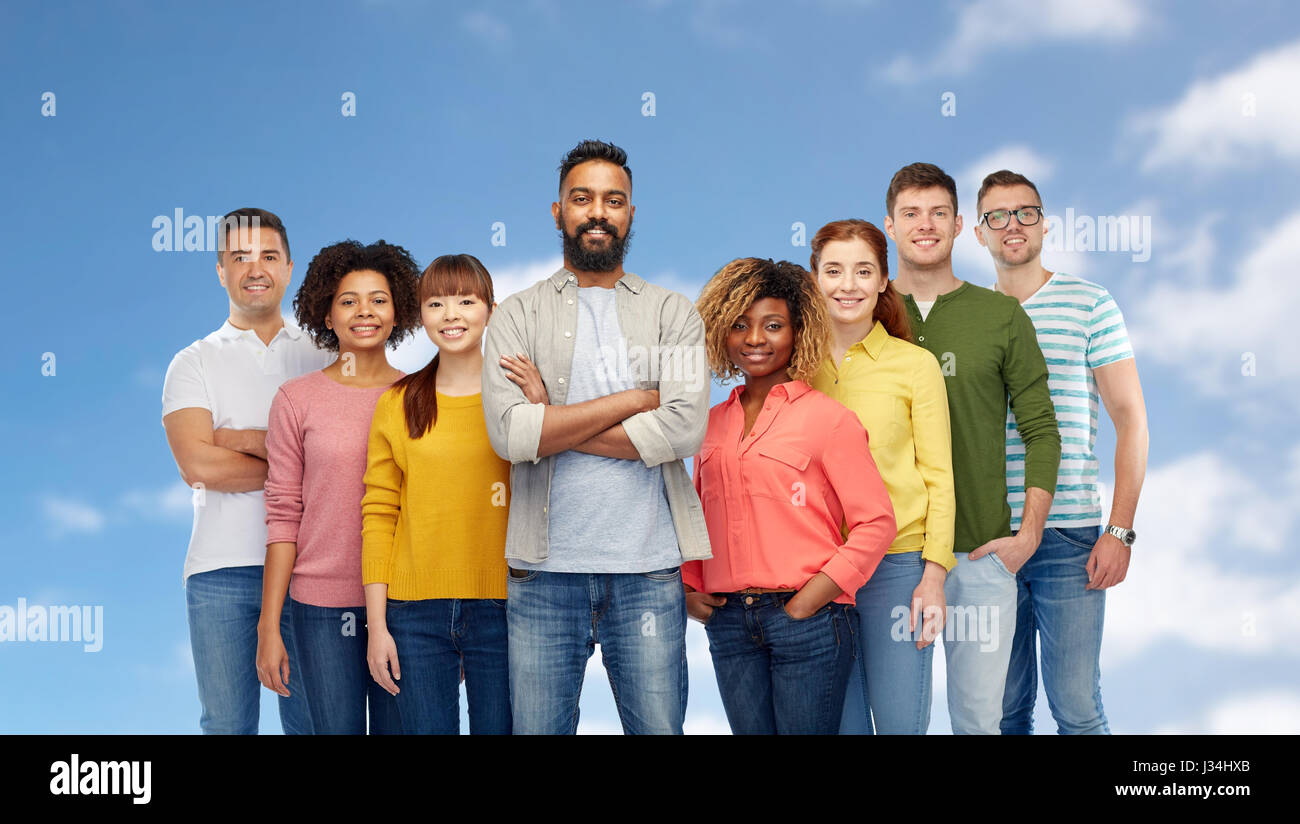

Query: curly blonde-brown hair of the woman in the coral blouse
[[696, 257, 831, 382]]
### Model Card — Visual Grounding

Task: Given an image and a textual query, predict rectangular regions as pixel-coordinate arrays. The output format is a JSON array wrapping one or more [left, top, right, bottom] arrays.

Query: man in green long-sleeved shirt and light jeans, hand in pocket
[[885, 162, 1061, 736]]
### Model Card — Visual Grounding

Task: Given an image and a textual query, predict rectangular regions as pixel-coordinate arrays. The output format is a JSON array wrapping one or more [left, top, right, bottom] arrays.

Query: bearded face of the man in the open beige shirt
[[551, 160, 636, 272]]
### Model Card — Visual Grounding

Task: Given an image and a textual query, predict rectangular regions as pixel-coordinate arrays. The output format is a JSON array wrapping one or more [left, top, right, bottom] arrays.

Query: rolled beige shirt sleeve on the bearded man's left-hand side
[[482, 295, 546, 464]]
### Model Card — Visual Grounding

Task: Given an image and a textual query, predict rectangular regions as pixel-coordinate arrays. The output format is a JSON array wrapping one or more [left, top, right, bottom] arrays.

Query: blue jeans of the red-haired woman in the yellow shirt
[[840, 550, 935, 736]]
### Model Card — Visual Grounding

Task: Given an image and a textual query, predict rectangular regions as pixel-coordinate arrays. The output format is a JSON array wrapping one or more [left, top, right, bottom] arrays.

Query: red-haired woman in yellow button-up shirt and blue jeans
[[811, 220, 957, 734]]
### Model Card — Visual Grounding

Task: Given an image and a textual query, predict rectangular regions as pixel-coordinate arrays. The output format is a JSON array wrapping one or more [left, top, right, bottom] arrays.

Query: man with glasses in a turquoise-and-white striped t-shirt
[[975, 169, 1147, 734]]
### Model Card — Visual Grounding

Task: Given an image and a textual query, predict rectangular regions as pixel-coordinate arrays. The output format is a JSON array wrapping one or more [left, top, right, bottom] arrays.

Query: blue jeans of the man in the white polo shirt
[[185, 567, 312, 736]]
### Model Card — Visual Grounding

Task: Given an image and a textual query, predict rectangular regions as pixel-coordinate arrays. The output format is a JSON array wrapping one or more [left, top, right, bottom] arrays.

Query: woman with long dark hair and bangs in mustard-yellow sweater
[[361, 255, 527, 734]]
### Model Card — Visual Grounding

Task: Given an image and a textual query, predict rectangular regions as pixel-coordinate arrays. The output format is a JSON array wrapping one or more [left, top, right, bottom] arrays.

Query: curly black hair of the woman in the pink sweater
[[294, 240, 420, 352]]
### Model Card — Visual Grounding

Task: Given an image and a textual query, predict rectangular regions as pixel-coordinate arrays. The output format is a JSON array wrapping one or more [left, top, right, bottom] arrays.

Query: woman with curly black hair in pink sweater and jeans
[[250, 240, 420, 734]]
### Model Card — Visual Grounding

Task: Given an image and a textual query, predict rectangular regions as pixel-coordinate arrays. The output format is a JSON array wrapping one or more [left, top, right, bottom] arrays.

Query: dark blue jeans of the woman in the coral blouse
[[705, 593, 858, 736]]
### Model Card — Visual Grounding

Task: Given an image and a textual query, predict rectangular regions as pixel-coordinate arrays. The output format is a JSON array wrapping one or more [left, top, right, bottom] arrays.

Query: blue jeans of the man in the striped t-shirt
[[1002, 526, 1110, 736]]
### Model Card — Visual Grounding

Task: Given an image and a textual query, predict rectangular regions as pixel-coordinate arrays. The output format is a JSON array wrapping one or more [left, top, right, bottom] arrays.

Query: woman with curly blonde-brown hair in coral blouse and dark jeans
[[681, 257, 894, 734]]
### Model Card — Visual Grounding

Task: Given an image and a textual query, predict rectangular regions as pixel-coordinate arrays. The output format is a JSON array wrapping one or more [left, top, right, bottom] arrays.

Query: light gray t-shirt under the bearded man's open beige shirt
[[511, 286, 681, 573]]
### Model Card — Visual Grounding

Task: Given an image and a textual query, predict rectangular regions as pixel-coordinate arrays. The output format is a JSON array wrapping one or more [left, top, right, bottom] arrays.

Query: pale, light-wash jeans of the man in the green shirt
[[944, 552, 1017, 736]]
